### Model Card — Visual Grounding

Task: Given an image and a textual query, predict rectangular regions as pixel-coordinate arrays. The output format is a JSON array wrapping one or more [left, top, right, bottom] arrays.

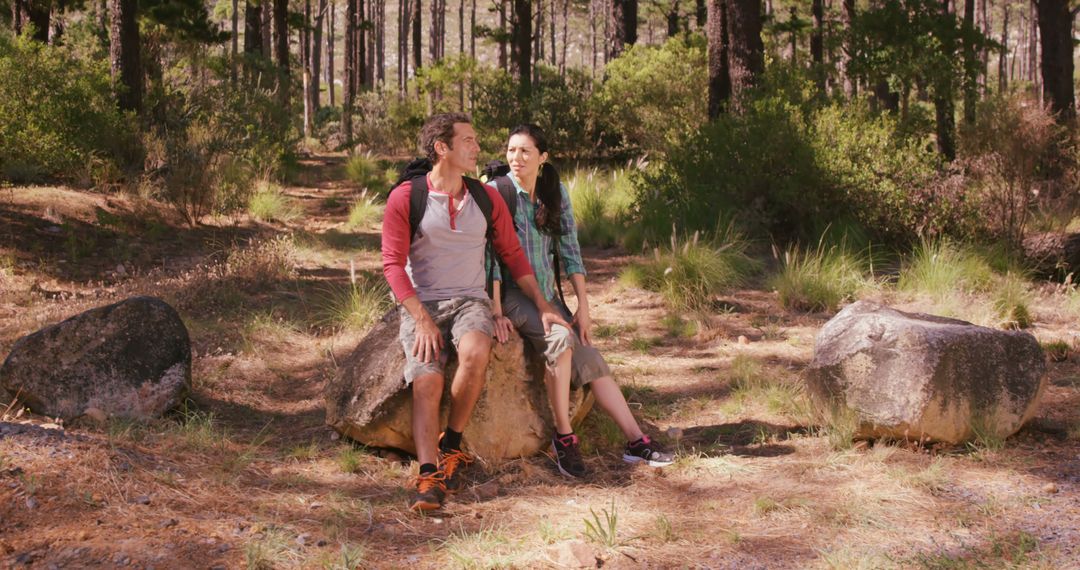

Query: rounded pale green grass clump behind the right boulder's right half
[[897, 241, 994, 300]]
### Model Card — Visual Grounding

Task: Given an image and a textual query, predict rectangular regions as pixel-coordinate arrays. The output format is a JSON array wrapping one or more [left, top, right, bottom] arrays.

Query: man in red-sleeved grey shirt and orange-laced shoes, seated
[[382, 113, 569, 511]]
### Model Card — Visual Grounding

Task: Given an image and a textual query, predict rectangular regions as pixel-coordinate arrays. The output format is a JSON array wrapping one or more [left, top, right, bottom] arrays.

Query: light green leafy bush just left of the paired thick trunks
[[591, 35, 708, 152]]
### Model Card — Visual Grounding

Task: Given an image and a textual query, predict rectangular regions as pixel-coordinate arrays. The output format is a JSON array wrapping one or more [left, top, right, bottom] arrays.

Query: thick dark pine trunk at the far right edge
[[1038, 0, 1076, 123]]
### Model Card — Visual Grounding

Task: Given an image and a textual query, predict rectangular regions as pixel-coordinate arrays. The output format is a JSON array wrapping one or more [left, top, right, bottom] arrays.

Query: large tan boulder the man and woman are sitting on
[[325, 311, 592, 461]]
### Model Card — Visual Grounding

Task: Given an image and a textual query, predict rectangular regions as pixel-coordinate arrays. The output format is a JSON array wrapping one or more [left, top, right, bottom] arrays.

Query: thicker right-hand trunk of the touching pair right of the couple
[[728, 0, 765, 108]]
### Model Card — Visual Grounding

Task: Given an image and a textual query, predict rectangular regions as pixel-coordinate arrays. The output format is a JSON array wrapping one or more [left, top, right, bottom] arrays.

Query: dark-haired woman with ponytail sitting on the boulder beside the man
[[494, 124, 673, 477]]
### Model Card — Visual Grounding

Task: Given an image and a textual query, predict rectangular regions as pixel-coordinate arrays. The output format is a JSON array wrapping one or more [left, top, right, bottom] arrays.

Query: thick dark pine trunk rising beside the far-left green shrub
[[109, 0, 143, 112]]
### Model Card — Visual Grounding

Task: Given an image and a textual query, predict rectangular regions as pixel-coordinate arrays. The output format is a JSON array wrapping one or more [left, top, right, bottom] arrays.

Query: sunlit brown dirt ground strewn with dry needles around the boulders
[[0, 157, 1080, 569]]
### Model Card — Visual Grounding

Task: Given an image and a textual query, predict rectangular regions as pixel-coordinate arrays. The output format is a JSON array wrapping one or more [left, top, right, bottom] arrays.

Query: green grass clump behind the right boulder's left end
[[770, 244, 873, 312]]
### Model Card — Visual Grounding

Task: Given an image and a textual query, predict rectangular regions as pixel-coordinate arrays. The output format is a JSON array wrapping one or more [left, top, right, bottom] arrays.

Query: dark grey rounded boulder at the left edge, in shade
[[0, 297, 191, 420]]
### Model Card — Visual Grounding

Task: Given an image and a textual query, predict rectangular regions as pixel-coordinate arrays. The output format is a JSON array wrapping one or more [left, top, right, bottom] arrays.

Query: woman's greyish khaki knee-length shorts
[[502, 287, 611, 388]]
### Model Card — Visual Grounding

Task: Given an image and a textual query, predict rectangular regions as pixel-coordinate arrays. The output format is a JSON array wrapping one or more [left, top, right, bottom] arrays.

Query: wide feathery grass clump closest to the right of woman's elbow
[[620, 230, 759, 312]]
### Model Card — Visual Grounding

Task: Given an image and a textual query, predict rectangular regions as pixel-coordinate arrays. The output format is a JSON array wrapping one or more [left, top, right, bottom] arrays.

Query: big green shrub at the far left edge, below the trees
[[0, 33, 138, 182]]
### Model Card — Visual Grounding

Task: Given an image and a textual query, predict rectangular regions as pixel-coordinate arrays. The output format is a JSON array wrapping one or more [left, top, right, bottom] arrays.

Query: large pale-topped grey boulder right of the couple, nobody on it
[[806, 301, 1047, 444]]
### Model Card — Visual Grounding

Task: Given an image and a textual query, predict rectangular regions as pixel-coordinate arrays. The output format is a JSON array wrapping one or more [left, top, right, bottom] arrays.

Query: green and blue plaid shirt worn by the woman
[[488, 174, 585, 301]]
